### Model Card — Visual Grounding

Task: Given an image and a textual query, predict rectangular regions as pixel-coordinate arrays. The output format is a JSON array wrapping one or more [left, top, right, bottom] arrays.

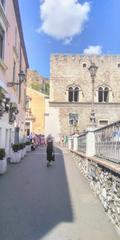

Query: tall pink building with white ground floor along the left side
[[0, 0, 29, 157]]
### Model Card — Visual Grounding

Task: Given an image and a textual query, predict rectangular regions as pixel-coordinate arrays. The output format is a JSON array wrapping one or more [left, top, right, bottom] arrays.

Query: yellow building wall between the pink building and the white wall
[[27, 88, 46, 134]]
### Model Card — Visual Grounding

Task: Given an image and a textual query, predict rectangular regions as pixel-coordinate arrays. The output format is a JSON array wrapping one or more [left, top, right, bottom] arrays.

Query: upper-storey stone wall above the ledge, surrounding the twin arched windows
[[50, 54, 120, 102]]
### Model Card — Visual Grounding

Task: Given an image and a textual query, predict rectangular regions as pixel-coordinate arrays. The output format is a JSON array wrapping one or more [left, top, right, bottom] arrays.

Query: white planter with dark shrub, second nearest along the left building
[[10, 144, 21, 163]]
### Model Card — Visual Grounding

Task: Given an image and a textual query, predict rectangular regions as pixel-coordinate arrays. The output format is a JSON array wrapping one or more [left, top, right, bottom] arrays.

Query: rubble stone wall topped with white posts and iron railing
[[69, 121, 120, 233]]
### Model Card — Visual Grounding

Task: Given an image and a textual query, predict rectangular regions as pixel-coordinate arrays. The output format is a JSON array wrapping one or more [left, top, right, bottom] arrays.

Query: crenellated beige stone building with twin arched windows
[[49, 54, 120, 140]]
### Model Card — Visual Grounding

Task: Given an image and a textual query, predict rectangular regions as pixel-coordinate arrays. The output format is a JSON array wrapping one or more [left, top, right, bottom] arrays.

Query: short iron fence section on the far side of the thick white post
[[78, 132, 87, 153]]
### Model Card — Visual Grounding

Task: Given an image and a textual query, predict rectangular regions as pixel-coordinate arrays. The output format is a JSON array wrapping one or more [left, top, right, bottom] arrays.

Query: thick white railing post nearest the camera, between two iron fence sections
[[86, 128, 96, 157]]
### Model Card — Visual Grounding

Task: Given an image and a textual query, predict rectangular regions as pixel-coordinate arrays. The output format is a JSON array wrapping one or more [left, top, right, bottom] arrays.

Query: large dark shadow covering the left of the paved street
[[0, 145, 74, 240]]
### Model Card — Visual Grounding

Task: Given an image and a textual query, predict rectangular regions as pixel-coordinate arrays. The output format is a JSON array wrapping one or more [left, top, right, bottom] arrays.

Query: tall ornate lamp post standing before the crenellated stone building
[[88, 62, 98, 126]]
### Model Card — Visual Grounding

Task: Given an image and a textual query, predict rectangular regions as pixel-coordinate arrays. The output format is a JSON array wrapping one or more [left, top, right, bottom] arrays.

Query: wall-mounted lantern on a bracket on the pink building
[[7, 70, 25, 103]]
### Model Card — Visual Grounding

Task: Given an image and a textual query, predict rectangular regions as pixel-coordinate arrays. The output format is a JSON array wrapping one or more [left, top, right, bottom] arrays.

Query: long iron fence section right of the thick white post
[[95, 121, 120, 163]]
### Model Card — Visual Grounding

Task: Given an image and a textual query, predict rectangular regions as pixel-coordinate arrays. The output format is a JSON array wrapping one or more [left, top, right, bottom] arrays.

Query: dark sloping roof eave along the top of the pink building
[[13, 0, 29, 68]]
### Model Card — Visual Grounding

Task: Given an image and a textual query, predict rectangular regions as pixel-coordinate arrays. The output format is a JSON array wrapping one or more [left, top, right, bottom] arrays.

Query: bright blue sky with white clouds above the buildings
[[19, 0, 120, 78]]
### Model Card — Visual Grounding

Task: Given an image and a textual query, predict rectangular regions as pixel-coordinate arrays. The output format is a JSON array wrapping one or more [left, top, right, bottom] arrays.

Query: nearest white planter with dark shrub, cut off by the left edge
[[0, 148, 7, 174]]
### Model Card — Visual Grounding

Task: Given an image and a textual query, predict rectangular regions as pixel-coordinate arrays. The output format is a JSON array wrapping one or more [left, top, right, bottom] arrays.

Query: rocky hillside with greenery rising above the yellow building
[[27, 69, 49, 95]]
